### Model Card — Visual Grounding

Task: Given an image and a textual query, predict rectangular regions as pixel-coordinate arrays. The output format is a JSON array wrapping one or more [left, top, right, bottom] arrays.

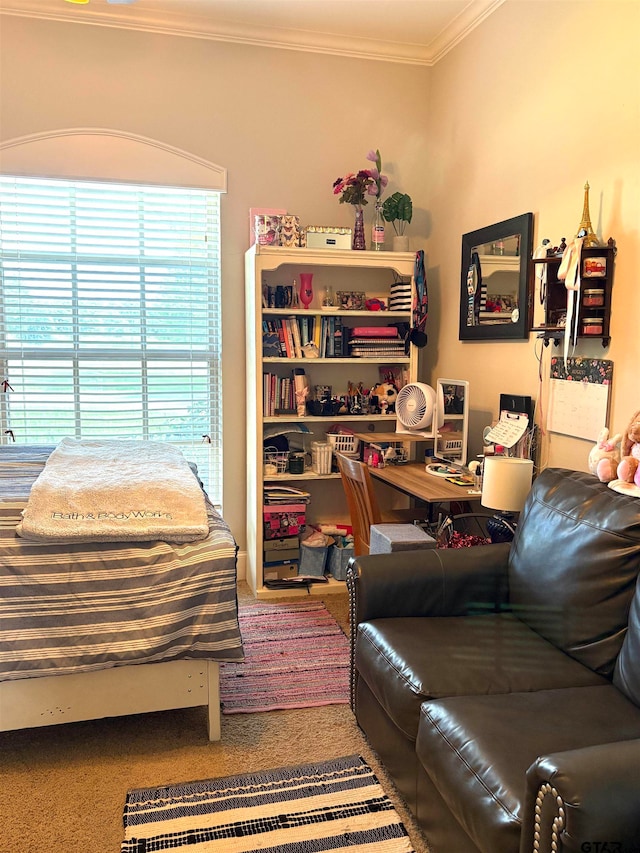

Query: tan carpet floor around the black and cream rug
[[0, 583, 429, 853]]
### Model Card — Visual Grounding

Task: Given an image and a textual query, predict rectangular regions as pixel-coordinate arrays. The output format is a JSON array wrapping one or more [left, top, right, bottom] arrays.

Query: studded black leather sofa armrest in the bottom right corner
[[520, 739, 640, 853]]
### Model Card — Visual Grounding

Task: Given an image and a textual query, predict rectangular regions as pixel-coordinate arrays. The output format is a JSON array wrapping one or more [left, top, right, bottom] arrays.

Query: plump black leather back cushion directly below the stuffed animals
[[509, 468, 640, 678]]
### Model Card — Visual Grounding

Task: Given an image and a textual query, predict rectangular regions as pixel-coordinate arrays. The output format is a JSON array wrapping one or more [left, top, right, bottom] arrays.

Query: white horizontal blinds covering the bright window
[[0, 176, 222, 503]]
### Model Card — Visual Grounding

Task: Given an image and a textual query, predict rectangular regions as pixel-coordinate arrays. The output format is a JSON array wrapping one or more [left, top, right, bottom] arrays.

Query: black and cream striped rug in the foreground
[[121, 755, 413, 853]]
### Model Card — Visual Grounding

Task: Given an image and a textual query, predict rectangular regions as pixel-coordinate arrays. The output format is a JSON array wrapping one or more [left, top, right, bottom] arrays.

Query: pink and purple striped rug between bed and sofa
[[220, 601, 349, 714]]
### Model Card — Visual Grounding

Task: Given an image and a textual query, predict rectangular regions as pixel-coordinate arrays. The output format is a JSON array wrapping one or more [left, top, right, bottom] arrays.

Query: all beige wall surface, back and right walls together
[[0, 0, 640, 560]]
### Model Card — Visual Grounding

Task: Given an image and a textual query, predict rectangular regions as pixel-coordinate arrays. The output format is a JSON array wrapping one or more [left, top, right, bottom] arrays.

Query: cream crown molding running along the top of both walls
[[0, 0, 505, 66]]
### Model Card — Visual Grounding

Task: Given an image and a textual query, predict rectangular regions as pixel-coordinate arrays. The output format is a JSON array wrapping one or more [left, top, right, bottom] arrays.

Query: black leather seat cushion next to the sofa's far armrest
[[355, 613, 606, 741]]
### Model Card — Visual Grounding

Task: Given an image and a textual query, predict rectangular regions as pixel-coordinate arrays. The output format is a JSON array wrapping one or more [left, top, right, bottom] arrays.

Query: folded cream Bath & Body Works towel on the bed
[[16, 438, 209, 542]]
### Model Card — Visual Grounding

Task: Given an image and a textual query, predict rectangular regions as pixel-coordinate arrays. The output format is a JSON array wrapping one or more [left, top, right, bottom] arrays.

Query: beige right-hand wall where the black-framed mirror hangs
[[426, 0, 640, 470]]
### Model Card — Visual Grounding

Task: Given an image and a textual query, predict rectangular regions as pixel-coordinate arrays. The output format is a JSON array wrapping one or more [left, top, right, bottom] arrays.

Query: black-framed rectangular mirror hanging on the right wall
[[458, 213, 533, 341]]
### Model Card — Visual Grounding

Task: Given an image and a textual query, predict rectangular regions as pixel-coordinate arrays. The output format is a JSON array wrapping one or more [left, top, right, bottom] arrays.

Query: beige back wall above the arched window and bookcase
[[0, 16, 429, 550]]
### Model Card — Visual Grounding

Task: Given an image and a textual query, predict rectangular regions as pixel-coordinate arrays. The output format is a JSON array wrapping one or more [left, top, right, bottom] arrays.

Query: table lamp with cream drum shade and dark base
[[480, 456, 533, 543]]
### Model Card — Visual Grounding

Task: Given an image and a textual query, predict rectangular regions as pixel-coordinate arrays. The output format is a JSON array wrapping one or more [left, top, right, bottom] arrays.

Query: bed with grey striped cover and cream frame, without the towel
[[0, 445, 243, 740]]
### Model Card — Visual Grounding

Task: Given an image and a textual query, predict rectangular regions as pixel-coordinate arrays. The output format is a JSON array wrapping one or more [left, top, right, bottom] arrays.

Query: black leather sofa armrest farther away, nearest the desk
[[347, 543, 510, 629]]
